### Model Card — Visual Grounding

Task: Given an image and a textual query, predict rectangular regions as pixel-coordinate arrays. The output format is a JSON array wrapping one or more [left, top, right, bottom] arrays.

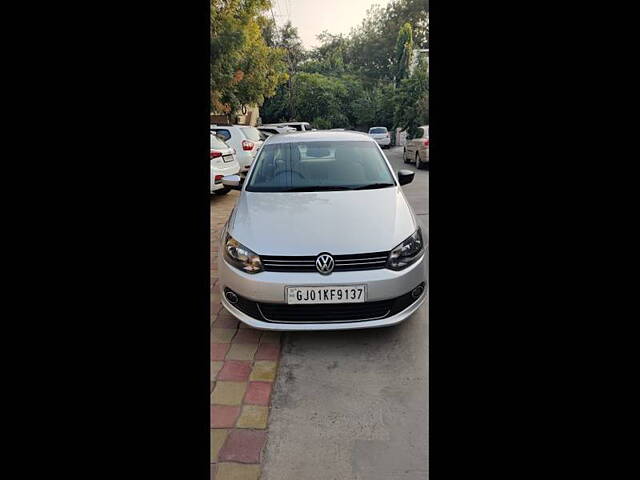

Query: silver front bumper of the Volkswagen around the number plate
[[219, 254, 428, 331]]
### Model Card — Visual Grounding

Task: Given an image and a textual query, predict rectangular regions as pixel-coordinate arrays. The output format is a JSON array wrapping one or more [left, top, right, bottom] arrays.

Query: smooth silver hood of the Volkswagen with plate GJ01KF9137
[[229, 187, 418, 256]]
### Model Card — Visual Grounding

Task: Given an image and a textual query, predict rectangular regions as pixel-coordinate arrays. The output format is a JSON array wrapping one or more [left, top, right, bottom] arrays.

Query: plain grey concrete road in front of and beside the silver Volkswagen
[[260, 147, 429, 480]]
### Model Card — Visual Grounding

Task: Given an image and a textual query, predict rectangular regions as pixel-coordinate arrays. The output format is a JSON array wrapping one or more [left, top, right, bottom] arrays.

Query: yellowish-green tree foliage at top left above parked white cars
[[210, 0, 287, 113]]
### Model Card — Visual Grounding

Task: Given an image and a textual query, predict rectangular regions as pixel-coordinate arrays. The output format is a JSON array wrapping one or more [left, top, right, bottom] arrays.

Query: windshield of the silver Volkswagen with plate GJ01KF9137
[[246, 141, 395, 192]]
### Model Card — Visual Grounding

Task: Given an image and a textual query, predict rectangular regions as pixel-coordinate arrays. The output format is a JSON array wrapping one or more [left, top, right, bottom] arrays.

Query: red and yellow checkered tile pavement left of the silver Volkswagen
[[211, 191, 280, 480]]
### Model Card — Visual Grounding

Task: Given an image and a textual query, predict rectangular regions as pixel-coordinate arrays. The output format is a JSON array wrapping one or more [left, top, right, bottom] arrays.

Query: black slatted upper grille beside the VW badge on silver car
[[260, 252, 389, 272]]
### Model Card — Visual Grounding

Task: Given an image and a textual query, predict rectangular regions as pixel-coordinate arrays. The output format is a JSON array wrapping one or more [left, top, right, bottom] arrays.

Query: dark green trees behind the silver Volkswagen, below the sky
[[261, 0, 429, 131]]
